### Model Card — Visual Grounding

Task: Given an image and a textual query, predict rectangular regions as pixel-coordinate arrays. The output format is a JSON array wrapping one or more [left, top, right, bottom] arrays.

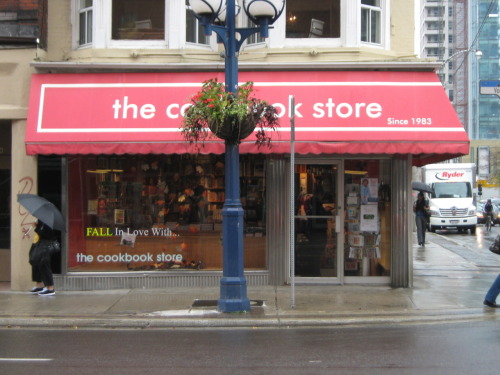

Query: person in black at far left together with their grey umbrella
[[17, 194, 66, 296]]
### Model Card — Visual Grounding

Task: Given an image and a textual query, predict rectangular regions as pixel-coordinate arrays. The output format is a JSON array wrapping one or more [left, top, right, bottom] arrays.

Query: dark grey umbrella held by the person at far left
[[17, 194, 66, 232]]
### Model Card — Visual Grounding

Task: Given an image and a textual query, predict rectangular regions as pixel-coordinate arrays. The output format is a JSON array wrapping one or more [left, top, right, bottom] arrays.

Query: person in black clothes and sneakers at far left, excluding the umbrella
[[29, 220, 58, 296]]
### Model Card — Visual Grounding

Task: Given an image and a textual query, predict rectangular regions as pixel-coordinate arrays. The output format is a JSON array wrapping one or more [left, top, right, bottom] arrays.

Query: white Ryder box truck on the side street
[[422, 163, 477, 234]]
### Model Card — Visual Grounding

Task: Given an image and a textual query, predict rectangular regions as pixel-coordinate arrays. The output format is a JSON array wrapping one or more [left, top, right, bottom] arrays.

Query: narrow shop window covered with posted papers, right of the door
[[344, 160, 391, 276]]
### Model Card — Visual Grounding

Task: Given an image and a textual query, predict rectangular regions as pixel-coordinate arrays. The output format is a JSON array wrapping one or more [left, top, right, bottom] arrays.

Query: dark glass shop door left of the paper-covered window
[[294, 161, 343, 278]]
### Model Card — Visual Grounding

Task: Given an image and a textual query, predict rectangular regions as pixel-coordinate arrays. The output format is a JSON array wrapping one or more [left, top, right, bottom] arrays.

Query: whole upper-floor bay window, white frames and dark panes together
[[76, 0, 390, 50]]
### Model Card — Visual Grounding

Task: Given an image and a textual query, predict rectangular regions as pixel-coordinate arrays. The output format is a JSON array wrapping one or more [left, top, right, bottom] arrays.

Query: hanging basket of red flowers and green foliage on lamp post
[[181, 79, 279, 147]]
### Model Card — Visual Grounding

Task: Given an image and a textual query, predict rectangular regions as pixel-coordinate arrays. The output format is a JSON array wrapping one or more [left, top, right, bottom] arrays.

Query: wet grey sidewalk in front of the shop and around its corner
[[0, 235, 500, 328]]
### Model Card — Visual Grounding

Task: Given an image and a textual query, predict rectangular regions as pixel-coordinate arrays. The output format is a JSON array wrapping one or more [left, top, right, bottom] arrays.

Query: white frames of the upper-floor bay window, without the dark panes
[[72, 0, 390, 51]]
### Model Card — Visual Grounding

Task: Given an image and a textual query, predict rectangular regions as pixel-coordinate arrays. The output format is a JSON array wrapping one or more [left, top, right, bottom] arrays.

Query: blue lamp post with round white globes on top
[[189, 0, 285, 312]]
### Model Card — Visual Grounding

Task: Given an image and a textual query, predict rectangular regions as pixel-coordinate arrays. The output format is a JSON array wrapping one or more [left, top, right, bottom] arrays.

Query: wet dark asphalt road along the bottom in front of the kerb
[[0, 321, 500, 375]]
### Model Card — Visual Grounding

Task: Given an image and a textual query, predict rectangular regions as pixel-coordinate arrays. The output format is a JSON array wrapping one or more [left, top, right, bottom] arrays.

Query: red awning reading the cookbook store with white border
[[26, 71, 469, 165]]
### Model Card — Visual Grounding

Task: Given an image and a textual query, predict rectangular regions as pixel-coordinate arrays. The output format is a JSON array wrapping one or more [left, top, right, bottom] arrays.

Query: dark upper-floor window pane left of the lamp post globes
[[111, 0, 165, 40]]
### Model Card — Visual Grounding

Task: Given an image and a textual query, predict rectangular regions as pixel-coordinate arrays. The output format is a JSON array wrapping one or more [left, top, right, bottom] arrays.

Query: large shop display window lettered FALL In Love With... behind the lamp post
[[68, 155, 266, 272]]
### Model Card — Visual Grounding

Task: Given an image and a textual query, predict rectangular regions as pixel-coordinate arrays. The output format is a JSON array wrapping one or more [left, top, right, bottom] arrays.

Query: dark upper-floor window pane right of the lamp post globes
[[286, 0, 341, 38]]
